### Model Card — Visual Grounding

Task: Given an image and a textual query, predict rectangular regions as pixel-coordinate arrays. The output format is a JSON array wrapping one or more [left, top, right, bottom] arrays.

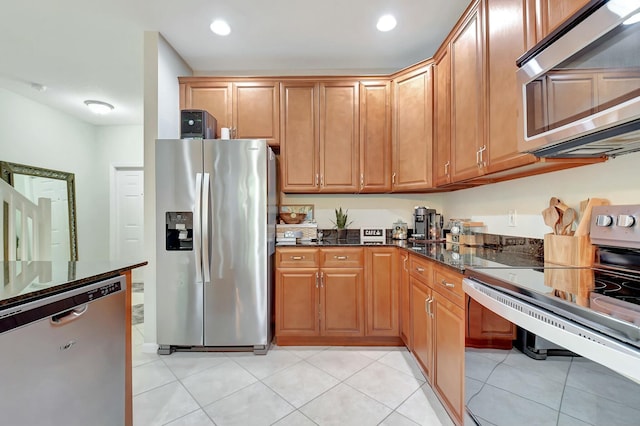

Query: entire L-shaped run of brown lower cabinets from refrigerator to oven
[[275, 247, 515, 425]]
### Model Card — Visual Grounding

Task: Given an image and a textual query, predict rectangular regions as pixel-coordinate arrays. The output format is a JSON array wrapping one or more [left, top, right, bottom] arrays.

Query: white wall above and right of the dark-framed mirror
[[0, 89, 141, 260]]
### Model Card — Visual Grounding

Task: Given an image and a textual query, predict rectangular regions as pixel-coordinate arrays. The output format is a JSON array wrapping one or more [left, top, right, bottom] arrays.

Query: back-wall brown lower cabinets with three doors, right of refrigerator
[[275, 247, 402, 345]]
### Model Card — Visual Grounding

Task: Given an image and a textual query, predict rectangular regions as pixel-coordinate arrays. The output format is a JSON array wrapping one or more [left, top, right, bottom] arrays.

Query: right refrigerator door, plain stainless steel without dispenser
[[203, 139, 275, 346]]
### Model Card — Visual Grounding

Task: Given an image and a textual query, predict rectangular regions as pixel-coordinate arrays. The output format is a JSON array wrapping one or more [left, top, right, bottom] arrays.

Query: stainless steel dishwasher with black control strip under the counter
[[0, 277, 126, 426]]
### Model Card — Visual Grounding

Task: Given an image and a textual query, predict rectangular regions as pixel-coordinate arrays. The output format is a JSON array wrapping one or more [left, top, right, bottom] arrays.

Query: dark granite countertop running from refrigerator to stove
[[277, 238, 544, 272]]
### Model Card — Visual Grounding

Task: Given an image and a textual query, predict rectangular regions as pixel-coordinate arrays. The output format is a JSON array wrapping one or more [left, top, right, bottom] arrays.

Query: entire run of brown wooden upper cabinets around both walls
[[179, 0, 604, 193]]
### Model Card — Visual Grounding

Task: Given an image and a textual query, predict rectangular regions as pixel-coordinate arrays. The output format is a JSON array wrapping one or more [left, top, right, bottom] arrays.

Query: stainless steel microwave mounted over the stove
[[517, 0, 640, 158]]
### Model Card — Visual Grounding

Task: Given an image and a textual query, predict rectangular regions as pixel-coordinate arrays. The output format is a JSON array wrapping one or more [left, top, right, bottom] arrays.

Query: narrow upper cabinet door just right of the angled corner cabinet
[[433, 44, 451, 186]]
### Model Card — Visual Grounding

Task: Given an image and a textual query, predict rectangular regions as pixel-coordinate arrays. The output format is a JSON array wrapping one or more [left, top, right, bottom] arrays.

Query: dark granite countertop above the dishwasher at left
[[0, 261, 147, 310]]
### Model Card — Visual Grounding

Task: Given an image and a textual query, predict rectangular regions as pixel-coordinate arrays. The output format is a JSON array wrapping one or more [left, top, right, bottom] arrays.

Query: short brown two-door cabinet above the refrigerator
[[179, 77, 280, 146]]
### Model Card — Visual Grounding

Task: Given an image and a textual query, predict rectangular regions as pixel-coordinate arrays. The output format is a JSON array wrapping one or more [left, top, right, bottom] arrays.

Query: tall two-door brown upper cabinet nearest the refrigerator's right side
[[280, 81, 360, 193]]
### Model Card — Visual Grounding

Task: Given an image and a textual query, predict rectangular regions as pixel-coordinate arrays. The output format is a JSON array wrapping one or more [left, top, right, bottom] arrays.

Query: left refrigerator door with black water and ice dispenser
[[156, 139, 203, 346]]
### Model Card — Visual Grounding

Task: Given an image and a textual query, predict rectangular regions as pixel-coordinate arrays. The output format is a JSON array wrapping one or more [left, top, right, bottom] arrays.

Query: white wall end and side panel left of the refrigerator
[[144, 31, 192, 351]]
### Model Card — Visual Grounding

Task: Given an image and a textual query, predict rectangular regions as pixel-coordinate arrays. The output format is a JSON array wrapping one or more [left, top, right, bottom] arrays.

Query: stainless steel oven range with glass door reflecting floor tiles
[[463, 205, 640, 425]]
